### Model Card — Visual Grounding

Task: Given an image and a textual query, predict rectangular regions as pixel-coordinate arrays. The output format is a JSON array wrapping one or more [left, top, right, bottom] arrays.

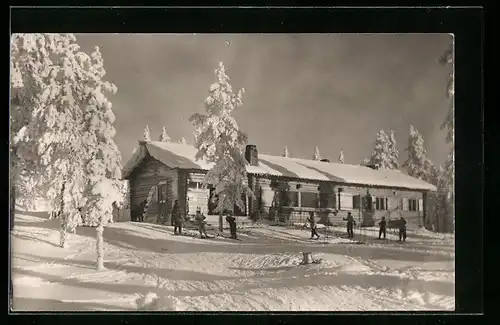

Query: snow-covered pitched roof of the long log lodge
[[123, 141, 436, 191]]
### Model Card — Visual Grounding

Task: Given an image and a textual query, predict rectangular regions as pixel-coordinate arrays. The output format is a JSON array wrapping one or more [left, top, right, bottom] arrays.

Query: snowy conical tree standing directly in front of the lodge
[[190, 62, 255, 231]]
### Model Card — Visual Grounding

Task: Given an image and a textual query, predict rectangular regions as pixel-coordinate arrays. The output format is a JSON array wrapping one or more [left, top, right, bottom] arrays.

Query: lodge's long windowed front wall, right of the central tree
[[255, 173, 426, 228]]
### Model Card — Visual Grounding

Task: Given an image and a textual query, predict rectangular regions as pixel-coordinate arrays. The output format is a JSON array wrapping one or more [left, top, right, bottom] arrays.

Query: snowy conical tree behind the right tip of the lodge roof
[[403, 125, 431, 181]]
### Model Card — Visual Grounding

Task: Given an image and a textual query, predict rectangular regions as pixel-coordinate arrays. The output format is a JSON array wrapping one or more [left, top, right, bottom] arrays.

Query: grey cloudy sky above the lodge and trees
[[77, 34, 450, 164]]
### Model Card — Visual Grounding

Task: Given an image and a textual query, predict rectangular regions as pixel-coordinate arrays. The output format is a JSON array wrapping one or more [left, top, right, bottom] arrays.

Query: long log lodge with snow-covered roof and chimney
[[123, 141, 436, 226]]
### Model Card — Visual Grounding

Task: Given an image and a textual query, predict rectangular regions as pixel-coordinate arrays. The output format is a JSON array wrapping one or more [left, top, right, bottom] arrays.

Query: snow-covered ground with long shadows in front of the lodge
[[11, 212, 455, 311]]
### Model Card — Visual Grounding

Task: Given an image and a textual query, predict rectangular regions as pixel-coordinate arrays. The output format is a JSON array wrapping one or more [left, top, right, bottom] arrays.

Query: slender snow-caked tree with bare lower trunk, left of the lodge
[[78, 47, 124, 269]]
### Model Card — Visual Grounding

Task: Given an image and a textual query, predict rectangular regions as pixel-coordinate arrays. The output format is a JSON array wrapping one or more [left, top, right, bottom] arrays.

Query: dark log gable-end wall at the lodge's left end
[[130, 156, 179, 222]]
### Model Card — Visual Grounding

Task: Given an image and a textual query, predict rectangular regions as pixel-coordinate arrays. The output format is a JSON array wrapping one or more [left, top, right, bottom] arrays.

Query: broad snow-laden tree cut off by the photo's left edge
[[11, 34, 91, 246]]
